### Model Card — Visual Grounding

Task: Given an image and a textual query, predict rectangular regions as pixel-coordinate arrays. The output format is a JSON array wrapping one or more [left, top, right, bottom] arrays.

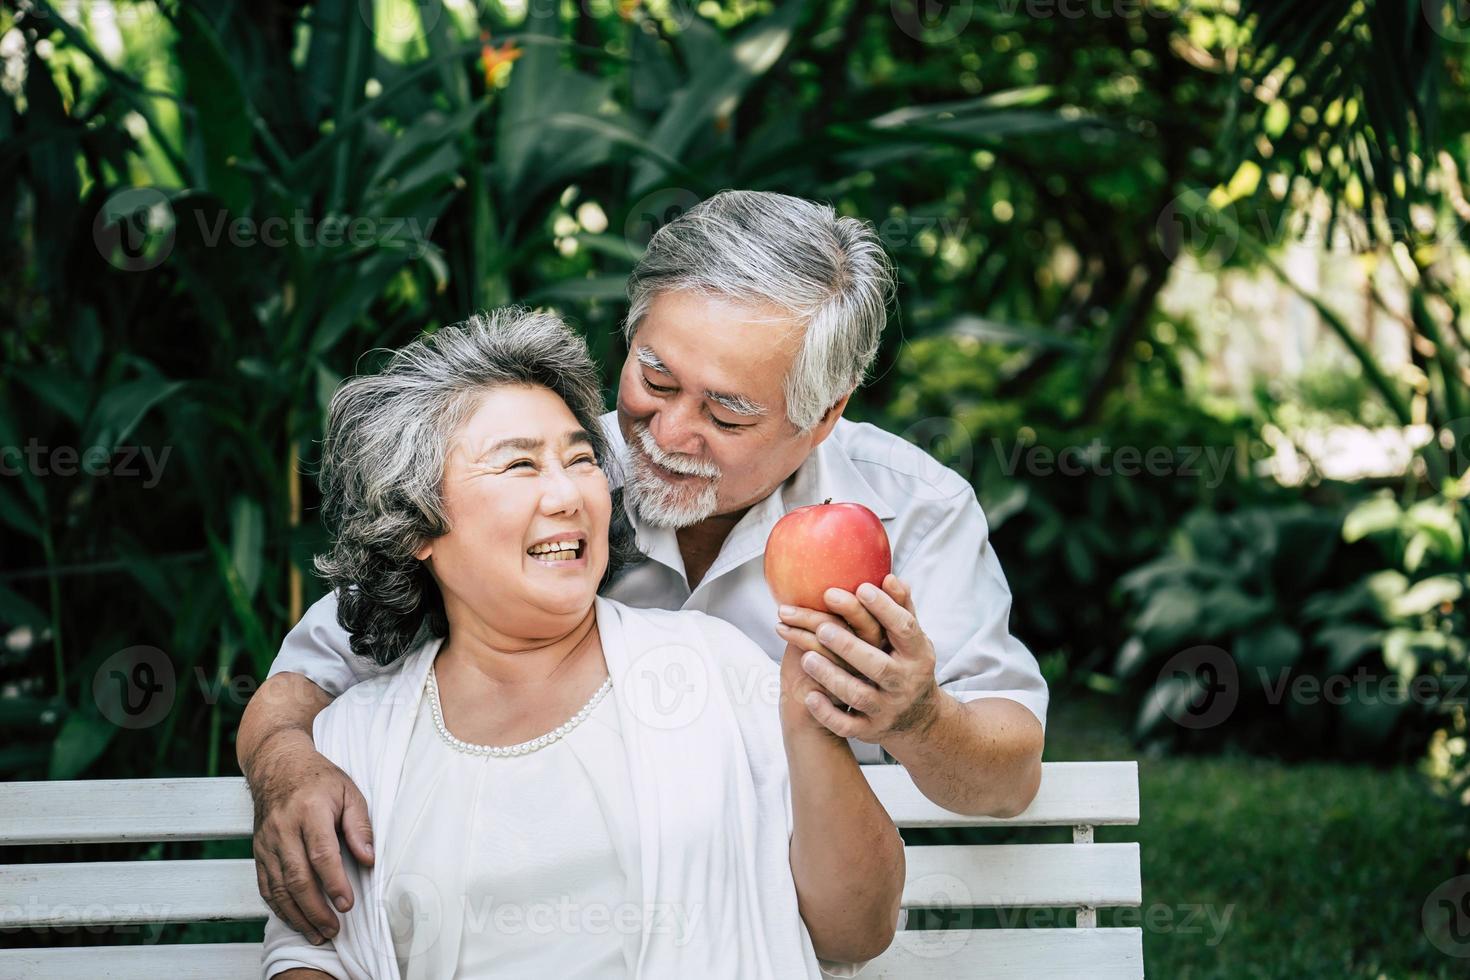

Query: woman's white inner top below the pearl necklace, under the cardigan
[[384, 673, 642, 980]]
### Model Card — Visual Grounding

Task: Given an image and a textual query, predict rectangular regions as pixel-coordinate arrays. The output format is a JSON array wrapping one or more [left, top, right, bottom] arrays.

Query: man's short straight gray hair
[[623, 191, 894, 432]]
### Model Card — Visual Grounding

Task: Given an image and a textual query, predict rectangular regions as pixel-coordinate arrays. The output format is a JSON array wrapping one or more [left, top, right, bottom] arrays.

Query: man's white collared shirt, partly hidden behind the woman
[[270, 411, 1048, 763]]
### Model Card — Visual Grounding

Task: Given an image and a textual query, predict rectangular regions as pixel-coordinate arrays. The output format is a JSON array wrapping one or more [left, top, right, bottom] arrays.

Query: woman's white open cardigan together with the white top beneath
[[262, 597, 860, 980]]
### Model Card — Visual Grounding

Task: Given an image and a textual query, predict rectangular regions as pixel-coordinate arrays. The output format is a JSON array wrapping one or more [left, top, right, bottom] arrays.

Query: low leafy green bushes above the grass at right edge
[[1114, 497, 1470, 755]]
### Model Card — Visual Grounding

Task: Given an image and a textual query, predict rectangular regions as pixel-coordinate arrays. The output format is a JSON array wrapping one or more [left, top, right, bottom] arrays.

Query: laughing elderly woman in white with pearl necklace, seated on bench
[[263, 310, 904, 980]]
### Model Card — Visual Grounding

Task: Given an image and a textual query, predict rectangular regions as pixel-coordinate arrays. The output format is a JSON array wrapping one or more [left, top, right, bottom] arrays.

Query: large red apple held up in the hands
[[766, 500, 892, 613]]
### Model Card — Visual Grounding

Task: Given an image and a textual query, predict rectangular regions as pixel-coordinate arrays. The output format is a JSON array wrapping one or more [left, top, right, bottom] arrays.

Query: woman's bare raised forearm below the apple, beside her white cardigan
[[786, 717, 904, 962]]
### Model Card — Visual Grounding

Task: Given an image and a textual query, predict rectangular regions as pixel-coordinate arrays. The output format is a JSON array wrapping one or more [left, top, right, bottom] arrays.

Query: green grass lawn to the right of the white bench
[[1047, 695, 1470, 980]]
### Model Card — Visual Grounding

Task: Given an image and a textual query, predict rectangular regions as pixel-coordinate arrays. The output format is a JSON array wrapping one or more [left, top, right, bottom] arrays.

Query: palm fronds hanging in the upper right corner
[[1186, 0, 1470, 494]]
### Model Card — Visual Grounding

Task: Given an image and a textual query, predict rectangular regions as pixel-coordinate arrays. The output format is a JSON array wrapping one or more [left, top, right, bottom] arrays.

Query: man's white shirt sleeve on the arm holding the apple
[[894, 486, 1050, 730]]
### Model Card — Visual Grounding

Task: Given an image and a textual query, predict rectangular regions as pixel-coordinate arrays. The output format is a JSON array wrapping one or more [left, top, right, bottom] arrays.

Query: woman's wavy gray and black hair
[[316, 307, 641, 664]]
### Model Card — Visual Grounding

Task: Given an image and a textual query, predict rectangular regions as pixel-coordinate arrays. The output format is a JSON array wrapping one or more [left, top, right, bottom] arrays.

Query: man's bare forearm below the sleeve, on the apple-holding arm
[[882, 691, 1045, 817]]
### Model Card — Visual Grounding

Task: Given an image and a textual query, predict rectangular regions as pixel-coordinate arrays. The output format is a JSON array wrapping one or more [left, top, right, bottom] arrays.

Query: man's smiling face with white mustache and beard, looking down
[[617, 291, 836, 527]]
